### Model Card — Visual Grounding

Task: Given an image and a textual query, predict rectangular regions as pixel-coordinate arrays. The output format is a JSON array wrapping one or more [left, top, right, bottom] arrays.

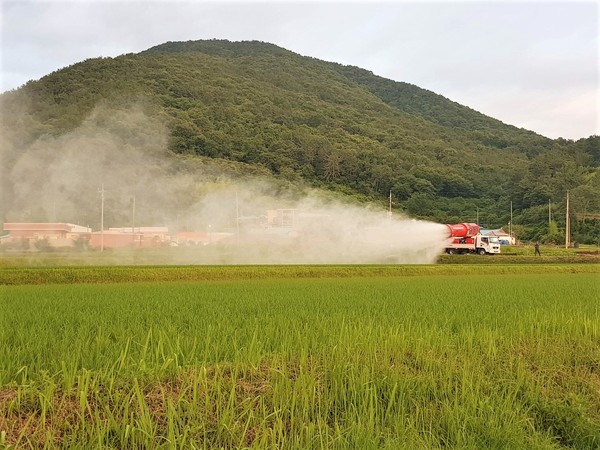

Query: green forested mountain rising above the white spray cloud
[[0, 40, 600, 242]]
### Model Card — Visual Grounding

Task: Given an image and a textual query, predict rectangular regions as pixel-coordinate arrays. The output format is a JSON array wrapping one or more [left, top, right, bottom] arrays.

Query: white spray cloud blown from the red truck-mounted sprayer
[[0, 106, 446, 264]]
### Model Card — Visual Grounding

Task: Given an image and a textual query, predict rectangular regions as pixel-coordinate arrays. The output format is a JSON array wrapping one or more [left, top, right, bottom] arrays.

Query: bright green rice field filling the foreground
[[0, 264, 600, 449]]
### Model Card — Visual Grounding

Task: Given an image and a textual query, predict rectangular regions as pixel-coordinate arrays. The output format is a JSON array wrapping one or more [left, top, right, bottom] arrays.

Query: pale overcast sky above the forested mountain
[[0, 0, 600, 139]]
